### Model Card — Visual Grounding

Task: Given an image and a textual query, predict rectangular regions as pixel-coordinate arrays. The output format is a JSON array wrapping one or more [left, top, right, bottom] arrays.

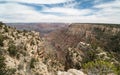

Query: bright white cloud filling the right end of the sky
[[94, 0, 120, 23]]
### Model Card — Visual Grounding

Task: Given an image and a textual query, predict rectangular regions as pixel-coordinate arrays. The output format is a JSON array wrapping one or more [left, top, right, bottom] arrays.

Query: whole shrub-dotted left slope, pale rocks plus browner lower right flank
[[0, 23, 64, 75]]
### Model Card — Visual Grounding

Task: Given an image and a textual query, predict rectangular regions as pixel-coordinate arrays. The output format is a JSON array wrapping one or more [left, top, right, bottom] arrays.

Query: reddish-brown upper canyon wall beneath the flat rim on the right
[[49, 23, 120, 49]]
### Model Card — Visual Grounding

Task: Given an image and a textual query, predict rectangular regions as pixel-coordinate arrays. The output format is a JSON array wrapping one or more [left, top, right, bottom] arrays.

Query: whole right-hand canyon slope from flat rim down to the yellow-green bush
[[49, 23, 120, 75]]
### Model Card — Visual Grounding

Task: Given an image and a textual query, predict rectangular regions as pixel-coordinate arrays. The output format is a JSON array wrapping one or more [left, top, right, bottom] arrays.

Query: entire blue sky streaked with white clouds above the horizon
[[0, 0, 120, 24]]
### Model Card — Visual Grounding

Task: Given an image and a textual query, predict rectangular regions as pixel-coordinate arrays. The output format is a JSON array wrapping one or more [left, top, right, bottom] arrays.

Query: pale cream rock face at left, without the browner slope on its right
[[0, 24, 53, 75]]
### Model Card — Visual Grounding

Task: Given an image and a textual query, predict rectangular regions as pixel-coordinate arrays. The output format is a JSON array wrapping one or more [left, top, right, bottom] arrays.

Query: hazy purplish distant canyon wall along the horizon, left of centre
[[7, 23, 69, 36]]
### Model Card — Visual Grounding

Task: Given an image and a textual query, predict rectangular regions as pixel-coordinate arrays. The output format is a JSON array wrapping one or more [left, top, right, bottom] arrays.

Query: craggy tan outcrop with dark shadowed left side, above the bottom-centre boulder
[[65, 48, 82, 70]]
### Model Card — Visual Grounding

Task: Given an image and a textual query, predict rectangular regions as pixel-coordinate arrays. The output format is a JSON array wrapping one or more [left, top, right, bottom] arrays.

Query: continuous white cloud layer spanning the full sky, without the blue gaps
[[0, 0, 120, 23]]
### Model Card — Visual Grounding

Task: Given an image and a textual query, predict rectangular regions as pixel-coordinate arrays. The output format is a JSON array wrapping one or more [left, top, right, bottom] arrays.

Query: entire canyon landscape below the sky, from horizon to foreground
[[0, 22, 120, 75]]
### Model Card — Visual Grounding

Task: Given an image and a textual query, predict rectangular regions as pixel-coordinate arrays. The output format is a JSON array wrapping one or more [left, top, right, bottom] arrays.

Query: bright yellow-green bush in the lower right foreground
[[83, 60, 117, 75]]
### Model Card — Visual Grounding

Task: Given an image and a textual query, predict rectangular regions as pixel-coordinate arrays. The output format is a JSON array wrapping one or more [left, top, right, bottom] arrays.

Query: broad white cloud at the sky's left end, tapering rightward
[[0, 3, 56, 22]]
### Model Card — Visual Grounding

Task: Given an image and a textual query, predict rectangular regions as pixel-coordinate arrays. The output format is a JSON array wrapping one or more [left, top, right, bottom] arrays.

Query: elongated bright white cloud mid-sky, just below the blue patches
[[42, 7, 92, 16]]
